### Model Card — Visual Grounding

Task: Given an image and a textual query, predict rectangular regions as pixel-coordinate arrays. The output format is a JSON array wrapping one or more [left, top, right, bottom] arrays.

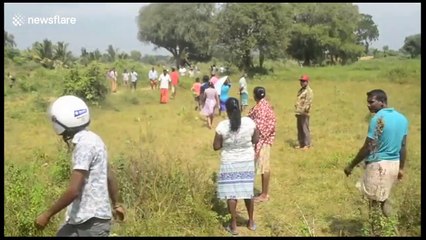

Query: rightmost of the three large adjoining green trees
[[287, 3, 364, 66]]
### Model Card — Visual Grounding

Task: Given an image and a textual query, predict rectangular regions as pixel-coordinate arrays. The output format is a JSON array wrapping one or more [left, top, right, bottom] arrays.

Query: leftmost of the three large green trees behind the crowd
[[137, 3, 216, 67]]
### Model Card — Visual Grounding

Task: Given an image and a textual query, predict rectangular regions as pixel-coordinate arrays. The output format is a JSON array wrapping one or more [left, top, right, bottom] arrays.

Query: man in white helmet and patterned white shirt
[[35, 96, 124, 237]]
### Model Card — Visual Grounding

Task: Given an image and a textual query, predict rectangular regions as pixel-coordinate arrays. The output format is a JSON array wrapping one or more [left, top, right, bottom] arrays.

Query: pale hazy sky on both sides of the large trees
[[4, 3, 421, 55]]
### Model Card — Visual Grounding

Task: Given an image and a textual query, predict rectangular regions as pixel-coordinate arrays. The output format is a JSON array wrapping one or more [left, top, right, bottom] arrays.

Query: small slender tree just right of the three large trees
[[356, 13, 379, 54]]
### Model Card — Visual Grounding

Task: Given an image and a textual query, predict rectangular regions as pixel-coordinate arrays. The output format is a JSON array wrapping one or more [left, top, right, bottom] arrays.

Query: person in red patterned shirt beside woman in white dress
[[248, 87, 277, 202]]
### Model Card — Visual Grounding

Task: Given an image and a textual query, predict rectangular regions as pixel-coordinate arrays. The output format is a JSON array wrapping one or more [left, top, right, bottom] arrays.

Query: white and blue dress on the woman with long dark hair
[[216, 117, 256, 199]]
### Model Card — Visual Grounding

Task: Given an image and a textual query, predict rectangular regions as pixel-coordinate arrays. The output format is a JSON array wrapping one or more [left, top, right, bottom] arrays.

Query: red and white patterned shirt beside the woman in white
[[248, 98, 277, 157]]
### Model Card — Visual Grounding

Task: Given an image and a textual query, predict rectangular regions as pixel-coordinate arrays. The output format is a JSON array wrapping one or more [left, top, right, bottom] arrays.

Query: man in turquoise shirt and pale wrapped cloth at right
[[344, 89, 408, 231]]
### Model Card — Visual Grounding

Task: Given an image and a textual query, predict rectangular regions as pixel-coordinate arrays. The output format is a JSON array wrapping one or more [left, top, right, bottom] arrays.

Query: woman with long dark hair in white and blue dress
[[213, 97, 259, 235]]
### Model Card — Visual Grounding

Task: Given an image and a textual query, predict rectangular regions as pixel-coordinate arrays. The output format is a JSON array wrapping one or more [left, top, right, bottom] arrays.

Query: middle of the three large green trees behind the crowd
[[217, 3, 290, 70]]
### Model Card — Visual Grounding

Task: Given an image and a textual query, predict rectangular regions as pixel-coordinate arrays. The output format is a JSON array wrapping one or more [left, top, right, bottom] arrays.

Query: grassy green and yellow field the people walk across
[[4, 58, 421, 236]]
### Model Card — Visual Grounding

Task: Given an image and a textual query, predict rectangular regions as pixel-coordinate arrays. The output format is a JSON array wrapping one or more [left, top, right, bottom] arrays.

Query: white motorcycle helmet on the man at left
[[48, 95, 90, 135]]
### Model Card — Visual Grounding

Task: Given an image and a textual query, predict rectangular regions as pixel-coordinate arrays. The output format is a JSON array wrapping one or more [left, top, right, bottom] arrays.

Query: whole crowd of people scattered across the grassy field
[[35, 64, 408, 236]]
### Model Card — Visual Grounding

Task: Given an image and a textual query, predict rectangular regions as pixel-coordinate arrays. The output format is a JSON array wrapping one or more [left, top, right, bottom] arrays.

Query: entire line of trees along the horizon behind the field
[[4, 3, 421, 71]]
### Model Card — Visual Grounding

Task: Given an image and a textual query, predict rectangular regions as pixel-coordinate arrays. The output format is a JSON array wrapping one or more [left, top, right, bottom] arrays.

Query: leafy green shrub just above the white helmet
[[63, 64, 107, 105]]
